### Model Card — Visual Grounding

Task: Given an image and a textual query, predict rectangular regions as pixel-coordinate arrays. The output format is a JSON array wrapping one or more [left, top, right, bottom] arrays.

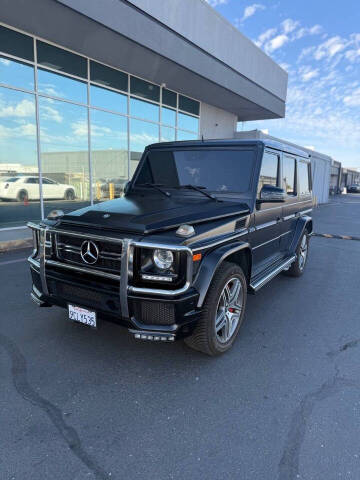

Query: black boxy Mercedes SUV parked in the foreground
[[29, 140, 312, 355]]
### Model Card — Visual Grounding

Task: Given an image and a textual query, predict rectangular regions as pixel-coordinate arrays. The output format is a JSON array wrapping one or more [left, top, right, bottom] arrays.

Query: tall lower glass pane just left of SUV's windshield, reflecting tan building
[[91, 110, 128, 200]]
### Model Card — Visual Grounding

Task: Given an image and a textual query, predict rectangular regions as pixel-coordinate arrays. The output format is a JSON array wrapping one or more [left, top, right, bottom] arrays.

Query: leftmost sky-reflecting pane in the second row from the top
[[0, 56, 34, 90]]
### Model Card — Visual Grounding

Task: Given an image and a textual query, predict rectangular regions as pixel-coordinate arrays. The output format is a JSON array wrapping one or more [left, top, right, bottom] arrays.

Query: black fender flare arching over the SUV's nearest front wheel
[[193, 242, 251, 308]]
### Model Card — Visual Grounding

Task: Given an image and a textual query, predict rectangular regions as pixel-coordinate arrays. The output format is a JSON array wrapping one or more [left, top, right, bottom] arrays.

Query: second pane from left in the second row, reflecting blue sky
[[38, 68, 87, 103]]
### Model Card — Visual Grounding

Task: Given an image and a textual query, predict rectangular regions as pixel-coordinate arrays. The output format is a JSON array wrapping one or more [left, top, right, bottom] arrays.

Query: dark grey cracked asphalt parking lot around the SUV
[[0, 195, 360, 480]]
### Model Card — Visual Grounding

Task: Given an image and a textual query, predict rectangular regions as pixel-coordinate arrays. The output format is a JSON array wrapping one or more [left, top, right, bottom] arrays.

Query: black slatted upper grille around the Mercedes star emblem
[[56, 233, 122, 275]]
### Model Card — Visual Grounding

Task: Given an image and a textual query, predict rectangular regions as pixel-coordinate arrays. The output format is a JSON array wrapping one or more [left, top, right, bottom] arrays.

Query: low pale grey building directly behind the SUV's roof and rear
[[235, 130, 333, 203]]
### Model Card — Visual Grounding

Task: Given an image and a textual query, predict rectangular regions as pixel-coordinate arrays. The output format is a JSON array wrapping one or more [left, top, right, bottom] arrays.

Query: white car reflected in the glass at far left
[[0, 177, 75, 202]]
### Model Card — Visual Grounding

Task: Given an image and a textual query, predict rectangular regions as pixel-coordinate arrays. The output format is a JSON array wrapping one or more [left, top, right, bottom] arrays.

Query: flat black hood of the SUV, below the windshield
[[60, 195, 249, 234]]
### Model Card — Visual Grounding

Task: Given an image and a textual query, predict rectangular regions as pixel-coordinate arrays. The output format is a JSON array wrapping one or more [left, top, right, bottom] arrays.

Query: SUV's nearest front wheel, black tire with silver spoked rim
[[184, 262, 247, 356]]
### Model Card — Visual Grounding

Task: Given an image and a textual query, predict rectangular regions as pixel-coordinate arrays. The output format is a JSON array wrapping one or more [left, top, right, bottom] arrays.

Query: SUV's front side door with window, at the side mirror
[[251, 150, 283, 275]]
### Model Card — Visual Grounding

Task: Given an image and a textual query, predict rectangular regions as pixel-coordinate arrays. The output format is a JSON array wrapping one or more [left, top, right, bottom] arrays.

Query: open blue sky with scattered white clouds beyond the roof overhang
[[207, 0, 360, 169]]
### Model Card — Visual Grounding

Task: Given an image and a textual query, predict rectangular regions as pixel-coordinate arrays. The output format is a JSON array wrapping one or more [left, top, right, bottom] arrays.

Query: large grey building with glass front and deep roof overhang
[[0, 0, 287, 227]]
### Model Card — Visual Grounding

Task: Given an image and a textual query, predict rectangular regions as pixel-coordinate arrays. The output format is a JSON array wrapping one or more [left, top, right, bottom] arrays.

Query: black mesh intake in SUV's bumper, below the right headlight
[[134, 301, 175, 325]]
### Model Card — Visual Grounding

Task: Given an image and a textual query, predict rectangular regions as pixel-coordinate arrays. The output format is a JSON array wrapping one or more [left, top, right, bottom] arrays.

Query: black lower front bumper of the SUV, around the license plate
[[30, 262, 201, 341]]
